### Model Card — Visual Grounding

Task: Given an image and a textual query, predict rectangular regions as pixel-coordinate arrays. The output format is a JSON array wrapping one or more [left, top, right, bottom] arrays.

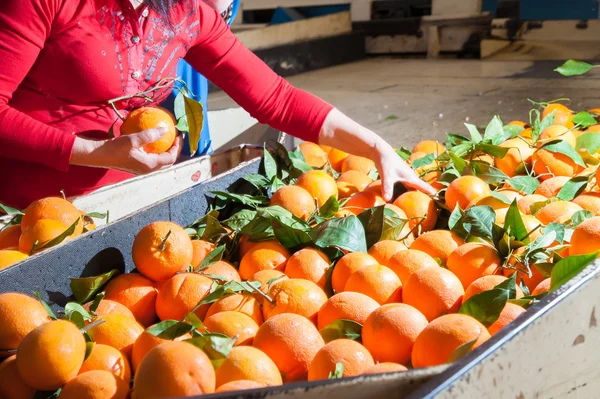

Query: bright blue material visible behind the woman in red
[[162, 0, 240, 156]]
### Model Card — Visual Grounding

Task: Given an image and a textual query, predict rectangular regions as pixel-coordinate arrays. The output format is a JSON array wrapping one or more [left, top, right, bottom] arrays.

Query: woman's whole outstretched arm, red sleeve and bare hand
[[186, 2, 435, 200]]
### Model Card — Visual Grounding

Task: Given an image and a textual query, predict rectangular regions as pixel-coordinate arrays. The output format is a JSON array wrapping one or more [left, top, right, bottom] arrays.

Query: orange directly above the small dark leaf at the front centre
[[318, 292, 379, 330]]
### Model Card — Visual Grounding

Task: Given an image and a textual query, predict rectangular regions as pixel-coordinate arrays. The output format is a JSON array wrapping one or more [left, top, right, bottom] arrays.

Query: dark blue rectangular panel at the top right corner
[[521, 0, 598, 20]]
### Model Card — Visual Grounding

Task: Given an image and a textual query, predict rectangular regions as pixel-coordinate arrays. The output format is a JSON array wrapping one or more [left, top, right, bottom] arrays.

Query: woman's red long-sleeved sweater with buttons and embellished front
[[0, 0, 332, 208]]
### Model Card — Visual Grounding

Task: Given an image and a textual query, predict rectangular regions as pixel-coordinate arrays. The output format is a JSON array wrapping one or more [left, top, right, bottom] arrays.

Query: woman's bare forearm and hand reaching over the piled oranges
[[319, 109, 436, 201]]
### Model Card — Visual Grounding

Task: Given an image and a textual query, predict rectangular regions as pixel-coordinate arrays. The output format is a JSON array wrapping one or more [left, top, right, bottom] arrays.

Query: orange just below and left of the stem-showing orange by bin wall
[[105, 273, 158, 326]]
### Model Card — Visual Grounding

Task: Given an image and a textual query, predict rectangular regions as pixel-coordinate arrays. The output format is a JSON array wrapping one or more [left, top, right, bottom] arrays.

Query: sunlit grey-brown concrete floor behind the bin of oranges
[[209, 57, 600, 147]]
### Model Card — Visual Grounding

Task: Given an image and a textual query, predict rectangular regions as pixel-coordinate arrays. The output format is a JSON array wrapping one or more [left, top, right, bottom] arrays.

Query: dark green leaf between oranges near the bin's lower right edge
[[458, 273, 516, 327]]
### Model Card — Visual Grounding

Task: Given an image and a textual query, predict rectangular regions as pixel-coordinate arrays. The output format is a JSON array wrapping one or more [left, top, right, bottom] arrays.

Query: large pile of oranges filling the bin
[[0, 101, 600, 399]]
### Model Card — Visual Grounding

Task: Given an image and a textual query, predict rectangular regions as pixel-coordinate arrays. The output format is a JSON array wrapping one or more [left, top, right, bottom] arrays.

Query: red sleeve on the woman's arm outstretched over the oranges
[[185, 4, 333, 142]]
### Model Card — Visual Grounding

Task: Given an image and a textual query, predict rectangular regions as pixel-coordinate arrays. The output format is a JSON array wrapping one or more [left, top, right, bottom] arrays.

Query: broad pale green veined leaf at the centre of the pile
[[310, 216, 367, 252]]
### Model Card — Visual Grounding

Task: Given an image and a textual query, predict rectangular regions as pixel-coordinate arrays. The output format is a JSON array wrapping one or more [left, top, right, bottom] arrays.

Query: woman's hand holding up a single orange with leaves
[[71, 128, 181, 174]]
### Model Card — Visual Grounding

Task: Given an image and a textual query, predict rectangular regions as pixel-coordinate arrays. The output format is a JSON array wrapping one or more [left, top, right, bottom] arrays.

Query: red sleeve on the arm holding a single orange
[[0, 0, 75, 171]]
